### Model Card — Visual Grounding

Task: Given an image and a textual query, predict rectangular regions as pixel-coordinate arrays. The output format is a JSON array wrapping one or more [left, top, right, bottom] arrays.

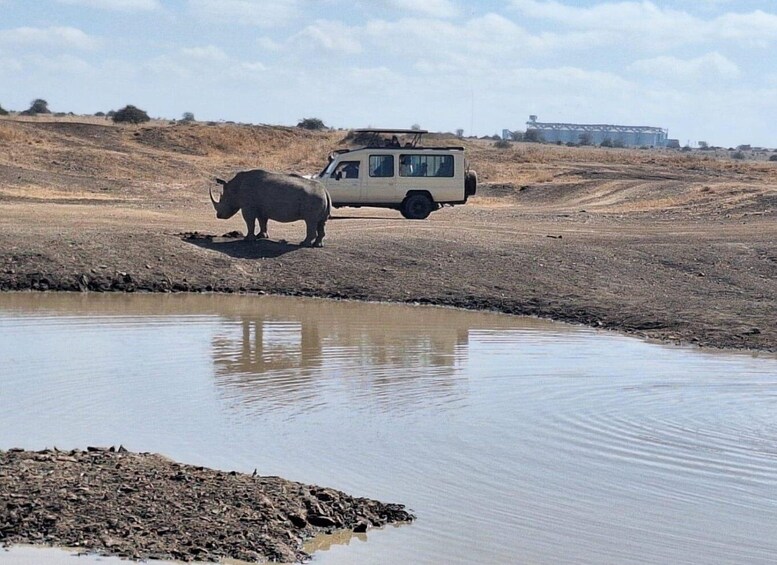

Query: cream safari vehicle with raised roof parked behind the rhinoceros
[[316, 129, 477, 220]]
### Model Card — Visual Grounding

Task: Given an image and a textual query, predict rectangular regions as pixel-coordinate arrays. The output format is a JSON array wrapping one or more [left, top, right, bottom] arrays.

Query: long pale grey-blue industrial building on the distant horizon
[[510, 116, 669, 147]]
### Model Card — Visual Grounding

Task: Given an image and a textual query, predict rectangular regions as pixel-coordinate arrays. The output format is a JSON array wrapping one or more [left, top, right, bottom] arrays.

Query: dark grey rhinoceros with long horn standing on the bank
[[209, 170, 332, 247]]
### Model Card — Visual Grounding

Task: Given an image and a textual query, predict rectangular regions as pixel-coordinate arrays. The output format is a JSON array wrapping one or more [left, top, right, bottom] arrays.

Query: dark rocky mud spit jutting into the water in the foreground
[[0, 447, 415, 562]]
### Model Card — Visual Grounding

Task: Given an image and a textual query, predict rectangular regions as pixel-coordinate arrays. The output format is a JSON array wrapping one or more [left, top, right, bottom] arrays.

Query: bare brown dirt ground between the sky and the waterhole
[[0, 120, 777, 351]]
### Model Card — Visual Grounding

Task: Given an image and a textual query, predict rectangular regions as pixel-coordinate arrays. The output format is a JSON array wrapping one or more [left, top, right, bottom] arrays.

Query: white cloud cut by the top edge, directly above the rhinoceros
[[189, 0, 302, 28]]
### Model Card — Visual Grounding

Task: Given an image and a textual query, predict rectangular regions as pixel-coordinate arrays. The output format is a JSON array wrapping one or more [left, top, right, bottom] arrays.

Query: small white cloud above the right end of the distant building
[[629, 52, 740, 81]]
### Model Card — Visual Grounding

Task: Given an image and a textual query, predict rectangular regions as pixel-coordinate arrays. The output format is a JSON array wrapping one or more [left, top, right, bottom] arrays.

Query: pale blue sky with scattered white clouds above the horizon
[[0, 0, 777, 147]]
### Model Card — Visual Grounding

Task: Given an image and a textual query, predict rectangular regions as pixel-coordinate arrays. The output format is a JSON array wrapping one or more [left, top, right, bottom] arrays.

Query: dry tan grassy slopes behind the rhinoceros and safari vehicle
[[0, 117, 777, 218]]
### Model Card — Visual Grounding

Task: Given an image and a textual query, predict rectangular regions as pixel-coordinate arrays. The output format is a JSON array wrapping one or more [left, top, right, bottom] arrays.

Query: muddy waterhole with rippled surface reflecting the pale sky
[[0, 294, 777, 564]]
